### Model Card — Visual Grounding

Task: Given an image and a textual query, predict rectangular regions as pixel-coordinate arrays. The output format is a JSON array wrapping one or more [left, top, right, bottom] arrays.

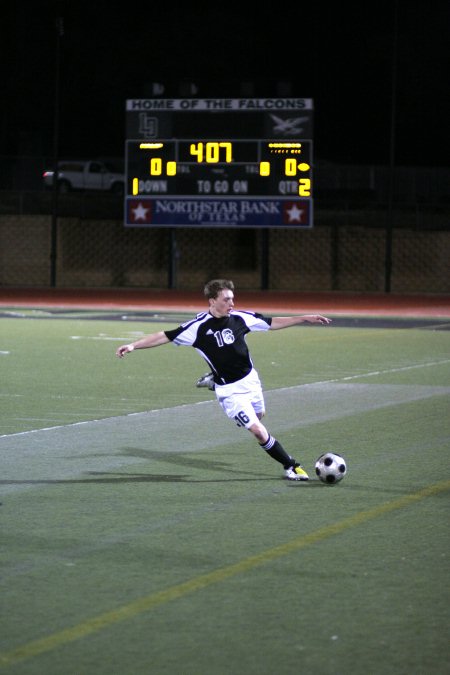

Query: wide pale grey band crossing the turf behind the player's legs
[[0, 382, 450, 493]]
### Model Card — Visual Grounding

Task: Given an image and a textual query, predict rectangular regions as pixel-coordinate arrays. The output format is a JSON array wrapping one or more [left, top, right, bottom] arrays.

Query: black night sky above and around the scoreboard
[[0, 0, 450, 166]]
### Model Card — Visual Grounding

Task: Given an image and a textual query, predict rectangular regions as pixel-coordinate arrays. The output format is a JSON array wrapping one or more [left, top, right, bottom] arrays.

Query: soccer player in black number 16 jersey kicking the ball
[[116, 279, 331, 481]]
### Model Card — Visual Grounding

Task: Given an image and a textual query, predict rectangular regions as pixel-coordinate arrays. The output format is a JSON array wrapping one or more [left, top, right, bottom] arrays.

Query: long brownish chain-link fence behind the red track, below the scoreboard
[[0, 202, 450, 293]]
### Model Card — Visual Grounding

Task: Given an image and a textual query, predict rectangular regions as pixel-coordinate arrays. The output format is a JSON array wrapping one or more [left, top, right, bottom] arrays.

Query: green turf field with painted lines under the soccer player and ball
[[0, 311, 450, 675]]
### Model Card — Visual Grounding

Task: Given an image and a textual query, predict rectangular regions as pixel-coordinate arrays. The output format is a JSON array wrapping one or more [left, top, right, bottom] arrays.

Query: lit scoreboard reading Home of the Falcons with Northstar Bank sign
[[125, 98, 313, 228]]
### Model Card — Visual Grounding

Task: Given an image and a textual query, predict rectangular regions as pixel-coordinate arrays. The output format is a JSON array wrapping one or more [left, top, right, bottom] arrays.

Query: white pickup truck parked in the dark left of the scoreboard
[[43, 160, 125, 195]]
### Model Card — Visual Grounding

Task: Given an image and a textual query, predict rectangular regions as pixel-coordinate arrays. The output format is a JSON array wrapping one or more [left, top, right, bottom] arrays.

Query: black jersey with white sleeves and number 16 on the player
[[164, 310, 272, 385]]
